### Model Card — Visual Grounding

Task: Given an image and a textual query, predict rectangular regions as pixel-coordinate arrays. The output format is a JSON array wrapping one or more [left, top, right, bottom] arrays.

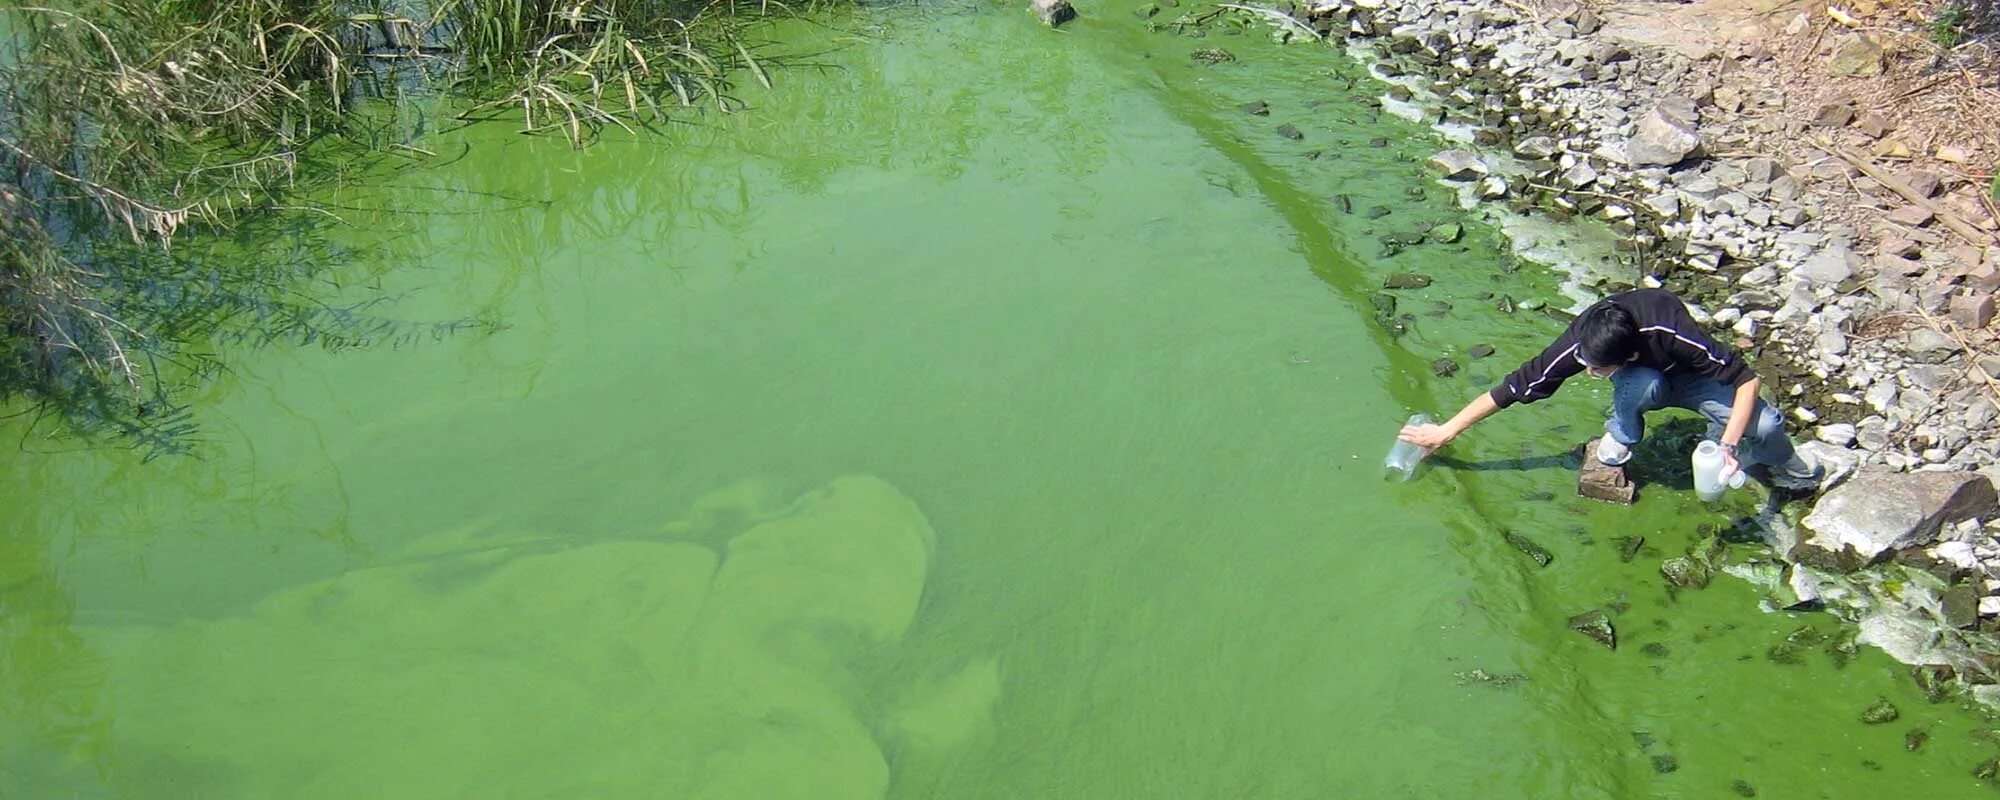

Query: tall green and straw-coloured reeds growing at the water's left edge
[[0, 0, 808, 454]]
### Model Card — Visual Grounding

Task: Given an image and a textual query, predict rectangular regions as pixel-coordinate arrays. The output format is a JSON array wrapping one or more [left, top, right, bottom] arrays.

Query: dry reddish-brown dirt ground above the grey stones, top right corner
[[1586, 0, 2000, 388]]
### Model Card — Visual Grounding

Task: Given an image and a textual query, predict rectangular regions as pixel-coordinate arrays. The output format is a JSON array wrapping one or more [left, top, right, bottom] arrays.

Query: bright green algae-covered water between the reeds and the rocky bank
[[11, 4, 2000, 798]]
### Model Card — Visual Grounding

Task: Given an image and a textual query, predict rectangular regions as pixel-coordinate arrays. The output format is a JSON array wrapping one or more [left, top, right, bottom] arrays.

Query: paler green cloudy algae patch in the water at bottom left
[[84, 478, 1000, 798]]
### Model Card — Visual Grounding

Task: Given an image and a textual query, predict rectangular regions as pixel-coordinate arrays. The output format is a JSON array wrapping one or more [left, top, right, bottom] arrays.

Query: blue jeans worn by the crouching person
[[1604, 366, 1792, 468]]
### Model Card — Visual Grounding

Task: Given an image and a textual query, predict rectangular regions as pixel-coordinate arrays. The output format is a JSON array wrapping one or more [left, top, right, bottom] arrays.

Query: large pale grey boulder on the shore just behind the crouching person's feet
[[1794, 470, 2000, 564]]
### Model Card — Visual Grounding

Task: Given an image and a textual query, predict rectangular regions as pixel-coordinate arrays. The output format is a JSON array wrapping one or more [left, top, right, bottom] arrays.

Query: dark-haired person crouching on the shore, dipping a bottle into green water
[[1400, 288, 1820, 490]]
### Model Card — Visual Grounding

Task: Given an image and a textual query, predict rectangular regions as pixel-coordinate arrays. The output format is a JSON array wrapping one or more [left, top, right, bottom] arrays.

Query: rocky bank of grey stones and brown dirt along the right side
[[1248, 0, 2000, 706]]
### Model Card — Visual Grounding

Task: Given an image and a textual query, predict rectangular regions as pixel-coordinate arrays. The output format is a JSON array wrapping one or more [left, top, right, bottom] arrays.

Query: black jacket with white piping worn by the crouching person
[[1486, 288, 1756, 408]]
